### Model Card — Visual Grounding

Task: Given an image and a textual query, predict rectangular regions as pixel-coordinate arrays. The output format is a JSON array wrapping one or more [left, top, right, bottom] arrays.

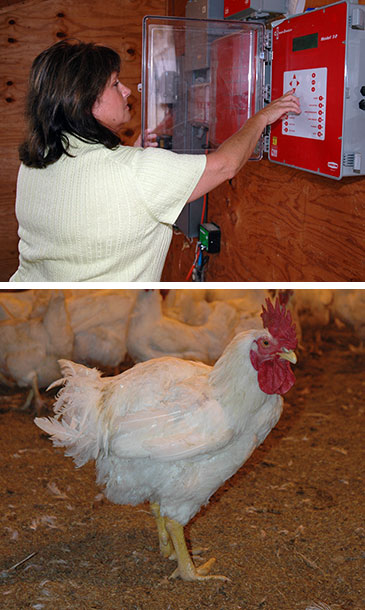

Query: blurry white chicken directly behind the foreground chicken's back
[[127, 290, 236, 364]]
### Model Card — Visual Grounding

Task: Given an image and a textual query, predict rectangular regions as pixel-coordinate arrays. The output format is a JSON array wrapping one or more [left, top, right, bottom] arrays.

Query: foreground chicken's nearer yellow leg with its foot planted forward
[[165, 517, 229, 580]]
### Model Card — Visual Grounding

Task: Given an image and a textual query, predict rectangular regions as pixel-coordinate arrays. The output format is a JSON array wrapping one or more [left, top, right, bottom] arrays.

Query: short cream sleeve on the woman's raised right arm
[[129, 147, 206, 224]]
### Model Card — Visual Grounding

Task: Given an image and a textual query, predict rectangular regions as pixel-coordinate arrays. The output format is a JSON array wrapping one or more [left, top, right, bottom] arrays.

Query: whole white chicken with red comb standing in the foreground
[[35, 300, 296, 581]]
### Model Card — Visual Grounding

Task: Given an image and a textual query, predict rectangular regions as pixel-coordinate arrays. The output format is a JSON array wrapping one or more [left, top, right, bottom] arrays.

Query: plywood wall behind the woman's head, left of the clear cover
[[0, 0, 167, 281]]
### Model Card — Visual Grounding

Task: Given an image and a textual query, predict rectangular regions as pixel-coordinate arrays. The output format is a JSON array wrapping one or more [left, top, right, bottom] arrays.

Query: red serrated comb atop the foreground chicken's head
[[261, 298, 297, 349]]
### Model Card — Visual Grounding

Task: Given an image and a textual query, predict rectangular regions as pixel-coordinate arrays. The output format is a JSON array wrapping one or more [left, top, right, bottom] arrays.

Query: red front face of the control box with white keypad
[[269, 2, 347, 178]]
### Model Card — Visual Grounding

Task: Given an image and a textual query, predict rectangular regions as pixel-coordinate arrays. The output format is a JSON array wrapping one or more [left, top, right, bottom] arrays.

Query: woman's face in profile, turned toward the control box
[[91, 72, 131, 133]]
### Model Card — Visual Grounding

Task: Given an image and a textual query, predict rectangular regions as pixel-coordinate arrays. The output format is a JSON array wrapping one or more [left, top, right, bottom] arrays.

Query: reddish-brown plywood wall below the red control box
[[163, 0, 365, 282]]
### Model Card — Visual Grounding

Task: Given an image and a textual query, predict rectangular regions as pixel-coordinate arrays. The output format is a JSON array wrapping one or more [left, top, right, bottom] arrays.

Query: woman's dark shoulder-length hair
[[19, 40, 120, 168]]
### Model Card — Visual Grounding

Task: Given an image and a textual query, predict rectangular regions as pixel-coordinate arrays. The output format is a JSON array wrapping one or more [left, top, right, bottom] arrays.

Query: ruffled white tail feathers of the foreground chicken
[[34, 360, 106, 466]]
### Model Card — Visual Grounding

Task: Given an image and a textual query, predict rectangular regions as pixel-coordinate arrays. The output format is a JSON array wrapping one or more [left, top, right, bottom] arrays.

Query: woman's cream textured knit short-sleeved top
[[10, 136, 206, 282]]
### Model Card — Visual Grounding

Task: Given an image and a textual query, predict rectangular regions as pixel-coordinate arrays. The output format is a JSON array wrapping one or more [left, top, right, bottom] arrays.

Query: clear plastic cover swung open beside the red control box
[[142, 17, 264, 159]]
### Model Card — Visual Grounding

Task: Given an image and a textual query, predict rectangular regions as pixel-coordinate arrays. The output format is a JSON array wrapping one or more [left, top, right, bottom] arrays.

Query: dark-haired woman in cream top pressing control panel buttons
[[10, 41, 300, 282]]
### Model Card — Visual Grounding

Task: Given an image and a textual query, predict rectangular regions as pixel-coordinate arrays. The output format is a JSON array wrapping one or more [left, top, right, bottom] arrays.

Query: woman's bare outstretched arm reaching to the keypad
[[189, 91, 300, 201]]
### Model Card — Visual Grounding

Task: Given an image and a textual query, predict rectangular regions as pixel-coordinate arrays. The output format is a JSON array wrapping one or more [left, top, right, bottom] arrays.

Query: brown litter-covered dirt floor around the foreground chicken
[[0, 327, 365, 610]]
